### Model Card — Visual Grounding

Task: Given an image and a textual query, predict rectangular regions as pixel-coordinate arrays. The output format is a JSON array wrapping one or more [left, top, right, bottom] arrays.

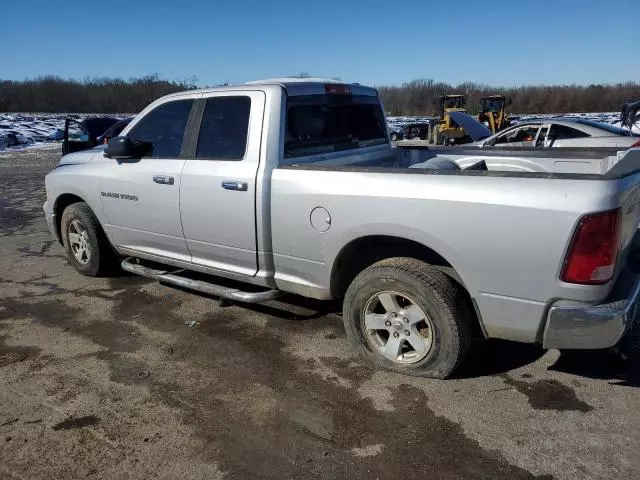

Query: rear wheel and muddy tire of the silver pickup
[[343, 258, 472, 378]]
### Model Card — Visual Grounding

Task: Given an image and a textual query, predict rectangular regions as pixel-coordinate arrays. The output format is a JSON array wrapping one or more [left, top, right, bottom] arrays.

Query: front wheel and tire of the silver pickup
[[60, 202, 118, 277]]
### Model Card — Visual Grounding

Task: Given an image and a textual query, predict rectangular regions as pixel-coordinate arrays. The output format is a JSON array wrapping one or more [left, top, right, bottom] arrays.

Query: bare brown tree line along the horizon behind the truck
[[0, 74, 640, 115]]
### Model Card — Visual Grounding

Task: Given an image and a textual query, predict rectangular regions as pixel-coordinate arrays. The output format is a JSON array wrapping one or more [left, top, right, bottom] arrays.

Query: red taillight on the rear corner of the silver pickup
[[561, 209, 620, 285]]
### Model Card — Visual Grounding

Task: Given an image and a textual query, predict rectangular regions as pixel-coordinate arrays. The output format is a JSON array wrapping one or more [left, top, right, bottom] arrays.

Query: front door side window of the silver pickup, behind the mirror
[[127, 99, 194, 158]]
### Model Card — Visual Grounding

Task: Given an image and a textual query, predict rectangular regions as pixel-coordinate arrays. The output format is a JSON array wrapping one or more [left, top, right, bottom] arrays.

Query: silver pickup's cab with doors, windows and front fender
[[43, 79, 390, 283]]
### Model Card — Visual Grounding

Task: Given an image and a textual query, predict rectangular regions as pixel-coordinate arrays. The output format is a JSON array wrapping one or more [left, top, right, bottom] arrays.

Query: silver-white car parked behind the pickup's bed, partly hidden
[[475, 118, 640, 148]]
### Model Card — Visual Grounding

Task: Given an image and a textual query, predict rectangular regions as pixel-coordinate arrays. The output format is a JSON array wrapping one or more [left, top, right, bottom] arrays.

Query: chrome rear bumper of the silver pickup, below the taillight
[[543, 275, 640, 349]]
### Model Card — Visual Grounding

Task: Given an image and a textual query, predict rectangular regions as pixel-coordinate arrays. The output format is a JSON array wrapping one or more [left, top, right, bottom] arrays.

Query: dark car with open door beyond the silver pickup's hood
[[62, 117, 133, 155]]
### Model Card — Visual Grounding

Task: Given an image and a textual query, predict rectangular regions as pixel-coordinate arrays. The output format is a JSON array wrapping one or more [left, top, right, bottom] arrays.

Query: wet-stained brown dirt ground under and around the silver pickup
[[0, 146, 640, 480]]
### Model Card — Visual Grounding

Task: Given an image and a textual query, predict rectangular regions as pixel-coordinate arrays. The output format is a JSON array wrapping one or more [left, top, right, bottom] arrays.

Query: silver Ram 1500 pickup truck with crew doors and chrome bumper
[[44, 80, 640, 378]]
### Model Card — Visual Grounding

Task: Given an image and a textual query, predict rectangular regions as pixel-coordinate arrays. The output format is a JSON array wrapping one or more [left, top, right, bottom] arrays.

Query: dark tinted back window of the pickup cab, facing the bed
[[284, 95, 387, 158]]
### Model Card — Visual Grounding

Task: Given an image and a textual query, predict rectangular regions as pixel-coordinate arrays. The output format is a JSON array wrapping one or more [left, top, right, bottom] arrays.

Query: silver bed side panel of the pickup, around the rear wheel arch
[[271, 168, 637, 341]]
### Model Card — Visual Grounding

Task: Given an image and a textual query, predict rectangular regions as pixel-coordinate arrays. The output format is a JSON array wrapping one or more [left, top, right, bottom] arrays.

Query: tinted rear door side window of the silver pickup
[[196, 96, 251, 160]]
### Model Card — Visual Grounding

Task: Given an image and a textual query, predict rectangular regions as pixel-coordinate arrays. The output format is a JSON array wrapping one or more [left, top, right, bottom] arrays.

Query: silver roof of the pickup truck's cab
[[162, 77, 378, 97]]
